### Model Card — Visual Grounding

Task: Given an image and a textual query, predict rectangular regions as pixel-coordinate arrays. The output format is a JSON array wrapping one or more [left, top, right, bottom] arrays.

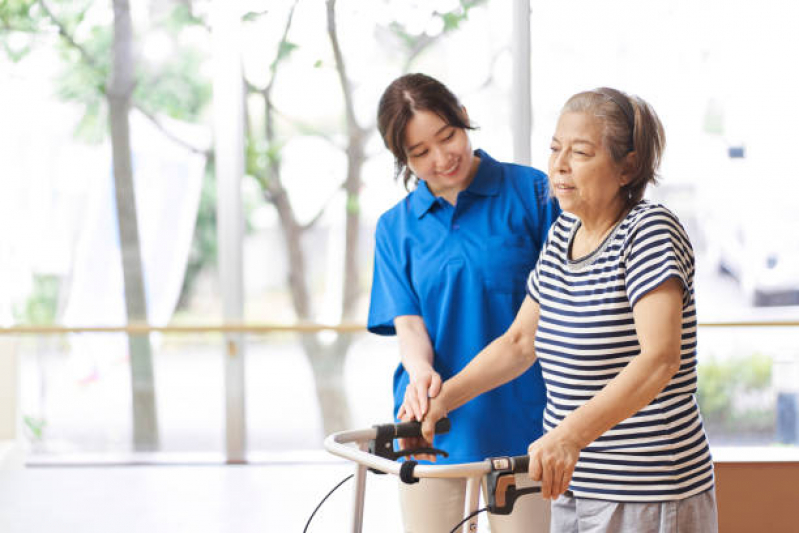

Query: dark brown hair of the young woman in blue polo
[[377, 74, 474, 190]]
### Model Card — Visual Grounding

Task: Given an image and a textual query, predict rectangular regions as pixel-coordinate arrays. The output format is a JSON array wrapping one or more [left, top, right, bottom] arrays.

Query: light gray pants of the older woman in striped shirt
[[550, 489, 719, 533]]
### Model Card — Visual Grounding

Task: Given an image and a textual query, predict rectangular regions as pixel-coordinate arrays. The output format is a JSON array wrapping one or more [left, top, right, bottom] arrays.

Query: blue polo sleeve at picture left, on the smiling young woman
[[366, 217, 421, 335]]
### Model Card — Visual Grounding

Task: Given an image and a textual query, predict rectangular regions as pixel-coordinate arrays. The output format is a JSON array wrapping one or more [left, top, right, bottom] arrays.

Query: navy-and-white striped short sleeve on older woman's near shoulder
[[625, 207, 694, 308]]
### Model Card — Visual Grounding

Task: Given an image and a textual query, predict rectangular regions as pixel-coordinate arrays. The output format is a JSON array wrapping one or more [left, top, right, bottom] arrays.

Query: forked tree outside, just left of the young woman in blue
[[246, 0, 484, 434]]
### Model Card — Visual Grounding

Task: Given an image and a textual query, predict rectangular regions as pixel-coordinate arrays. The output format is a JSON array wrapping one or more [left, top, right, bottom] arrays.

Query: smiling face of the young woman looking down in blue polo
[[405, 111, 479, 196]]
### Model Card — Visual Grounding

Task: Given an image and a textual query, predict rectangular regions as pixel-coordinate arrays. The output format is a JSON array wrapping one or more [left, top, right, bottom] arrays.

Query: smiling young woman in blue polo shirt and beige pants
[[368, 74, 560, 533]]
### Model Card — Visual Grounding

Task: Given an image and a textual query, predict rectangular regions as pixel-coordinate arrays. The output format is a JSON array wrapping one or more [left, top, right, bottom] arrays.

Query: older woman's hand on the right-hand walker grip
[[527, 428, 580, 500]]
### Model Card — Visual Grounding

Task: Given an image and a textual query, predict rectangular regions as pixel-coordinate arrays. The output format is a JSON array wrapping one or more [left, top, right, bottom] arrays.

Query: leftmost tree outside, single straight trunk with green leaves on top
[[0, 0, 211, 451]]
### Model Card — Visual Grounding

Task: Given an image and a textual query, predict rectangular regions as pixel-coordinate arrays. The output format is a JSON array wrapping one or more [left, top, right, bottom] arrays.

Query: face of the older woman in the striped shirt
[[549, 112, 628, 221]]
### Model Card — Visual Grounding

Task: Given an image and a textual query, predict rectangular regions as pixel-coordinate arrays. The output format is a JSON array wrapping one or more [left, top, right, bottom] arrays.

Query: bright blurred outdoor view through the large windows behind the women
[[0, 0, 799, 464]]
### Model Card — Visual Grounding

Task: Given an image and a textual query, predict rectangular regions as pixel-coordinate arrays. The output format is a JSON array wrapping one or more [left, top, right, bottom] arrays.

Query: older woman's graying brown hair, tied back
[[561, 87, 666, 209]]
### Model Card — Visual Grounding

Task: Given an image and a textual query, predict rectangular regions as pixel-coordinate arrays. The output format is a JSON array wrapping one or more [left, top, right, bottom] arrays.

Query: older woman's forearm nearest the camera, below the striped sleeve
[[554, 353, 679, 449]]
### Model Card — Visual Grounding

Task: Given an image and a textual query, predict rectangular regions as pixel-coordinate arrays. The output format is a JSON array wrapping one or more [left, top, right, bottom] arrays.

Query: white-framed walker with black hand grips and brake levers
[[322, 418, 541, 533]]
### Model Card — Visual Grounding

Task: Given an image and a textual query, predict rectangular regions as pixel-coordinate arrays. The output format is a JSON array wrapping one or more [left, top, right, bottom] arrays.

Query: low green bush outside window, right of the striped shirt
[[697, 353, 773, 431]]
